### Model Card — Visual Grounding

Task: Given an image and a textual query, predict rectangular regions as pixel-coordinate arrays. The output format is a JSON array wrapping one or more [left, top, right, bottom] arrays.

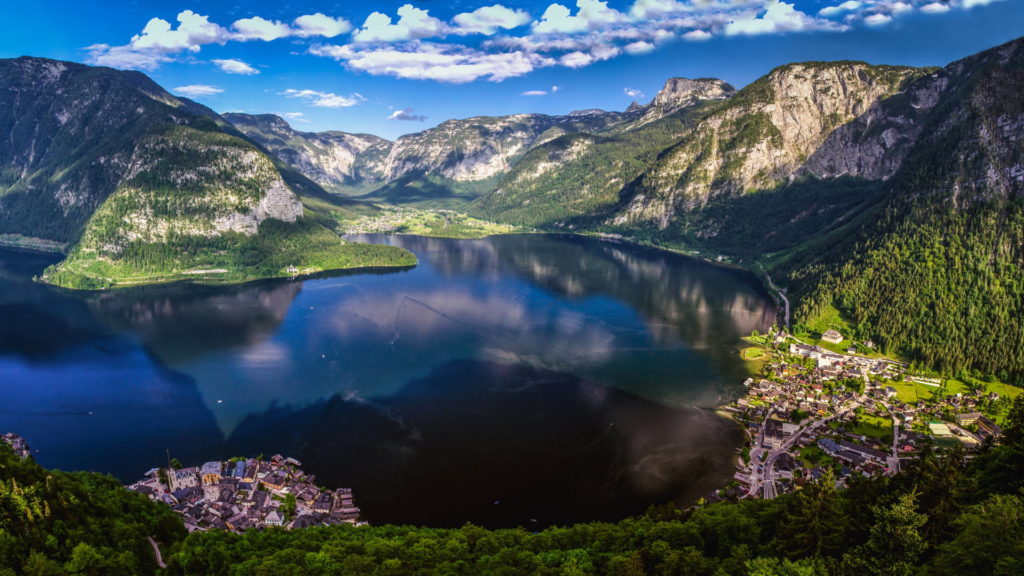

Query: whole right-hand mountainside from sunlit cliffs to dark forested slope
[[470, 40, 1024, 379]]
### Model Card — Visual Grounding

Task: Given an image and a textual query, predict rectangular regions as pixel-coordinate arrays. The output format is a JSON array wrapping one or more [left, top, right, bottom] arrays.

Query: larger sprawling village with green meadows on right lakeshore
[[708, 329, 1021, 501]]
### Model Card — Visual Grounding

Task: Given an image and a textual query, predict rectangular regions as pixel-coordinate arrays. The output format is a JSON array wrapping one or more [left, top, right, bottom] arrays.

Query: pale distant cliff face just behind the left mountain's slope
[[224, 114, 391, 194]]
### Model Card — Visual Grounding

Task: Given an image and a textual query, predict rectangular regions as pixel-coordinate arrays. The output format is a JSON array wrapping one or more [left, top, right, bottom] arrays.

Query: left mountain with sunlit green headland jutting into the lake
[[0, 57, 414, 288]]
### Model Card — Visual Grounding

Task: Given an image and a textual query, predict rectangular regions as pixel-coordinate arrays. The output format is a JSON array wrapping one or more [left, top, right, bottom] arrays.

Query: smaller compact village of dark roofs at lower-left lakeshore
[[127, 454, 365, 532]]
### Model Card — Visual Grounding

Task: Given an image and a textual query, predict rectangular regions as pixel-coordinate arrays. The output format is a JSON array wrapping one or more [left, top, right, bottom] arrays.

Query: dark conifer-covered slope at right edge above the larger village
[[778, 35, 1024, 379]]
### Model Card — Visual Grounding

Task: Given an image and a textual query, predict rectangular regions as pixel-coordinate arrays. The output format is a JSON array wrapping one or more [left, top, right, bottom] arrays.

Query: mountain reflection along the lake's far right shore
[[356, 235, 775, 348]]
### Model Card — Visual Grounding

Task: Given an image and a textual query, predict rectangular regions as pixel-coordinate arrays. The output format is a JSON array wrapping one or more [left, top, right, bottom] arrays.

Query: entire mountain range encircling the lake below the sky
[[0, 35, 1024, 378]]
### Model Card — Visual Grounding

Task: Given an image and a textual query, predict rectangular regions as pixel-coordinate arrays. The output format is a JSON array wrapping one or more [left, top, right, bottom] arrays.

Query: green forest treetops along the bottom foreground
[[0, 397, 1024, 576]]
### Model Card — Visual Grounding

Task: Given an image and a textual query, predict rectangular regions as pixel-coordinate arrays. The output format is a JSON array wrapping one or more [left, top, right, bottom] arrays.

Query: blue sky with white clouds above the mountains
[[0, 0, 1024, 138]]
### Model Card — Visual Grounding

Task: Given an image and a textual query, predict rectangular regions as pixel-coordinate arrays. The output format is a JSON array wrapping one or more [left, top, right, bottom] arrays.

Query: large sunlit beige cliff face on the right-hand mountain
[[612, 63, 920, 229]]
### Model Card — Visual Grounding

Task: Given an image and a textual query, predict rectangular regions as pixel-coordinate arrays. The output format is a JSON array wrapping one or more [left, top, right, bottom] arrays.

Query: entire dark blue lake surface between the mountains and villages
[[0, 236, 774, 527]]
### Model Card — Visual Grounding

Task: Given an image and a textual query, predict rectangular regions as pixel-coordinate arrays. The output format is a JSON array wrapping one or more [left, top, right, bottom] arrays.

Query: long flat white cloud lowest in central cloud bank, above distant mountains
[[309, 42, 554, 84]]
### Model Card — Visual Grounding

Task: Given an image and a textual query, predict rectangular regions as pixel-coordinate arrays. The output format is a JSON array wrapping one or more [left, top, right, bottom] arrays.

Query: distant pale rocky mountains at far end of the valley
[[224, 78, 733, 207]]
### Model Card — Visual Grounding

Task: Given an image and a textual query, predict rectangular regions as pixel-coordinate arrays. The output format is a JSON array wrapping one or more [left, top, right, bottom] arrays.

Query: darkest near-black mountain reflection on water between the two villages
[[228, 361, 739, 526]]
